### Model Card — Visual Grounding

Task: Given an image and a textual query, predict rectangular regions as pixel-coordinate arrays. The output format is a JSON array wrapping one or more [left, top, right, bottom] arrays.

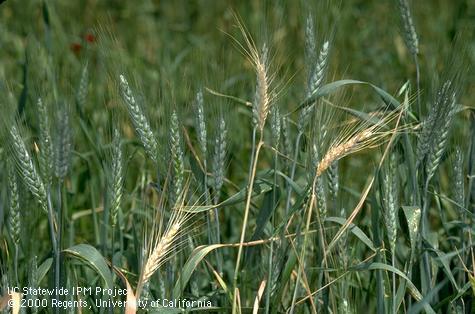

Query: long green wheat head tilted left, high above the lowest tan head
[[119, 74, 158, 163]]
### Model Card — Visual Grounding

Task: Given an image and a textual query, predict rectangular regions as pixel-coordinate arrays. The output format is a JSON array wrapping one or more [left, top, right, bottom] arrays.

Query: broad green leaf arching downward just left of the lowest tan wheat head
[[63, 244, 114, 289]]
